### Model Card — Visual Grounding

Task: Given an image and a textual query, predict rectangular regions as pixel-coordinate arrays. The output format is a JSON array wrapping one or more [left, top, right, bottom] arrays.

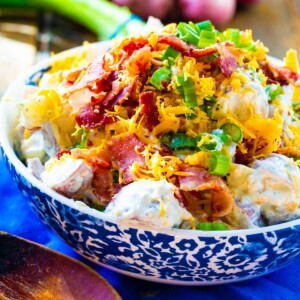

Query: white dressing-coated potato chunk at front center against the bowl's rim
[[105, 180, 192, 228]]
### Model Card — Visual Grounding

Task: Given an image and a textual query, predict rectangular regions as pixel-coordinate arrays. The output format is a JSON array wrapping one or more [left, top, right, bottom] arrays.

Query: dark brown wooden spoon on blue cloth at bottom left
[[0, 232, 121, 300]]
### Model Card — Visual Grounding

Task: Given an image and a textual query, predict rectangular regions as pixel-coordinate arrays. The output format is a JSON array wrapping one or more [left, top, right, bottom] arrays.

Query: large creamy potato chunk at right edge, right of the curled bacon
[[227, 154, 300, 224]]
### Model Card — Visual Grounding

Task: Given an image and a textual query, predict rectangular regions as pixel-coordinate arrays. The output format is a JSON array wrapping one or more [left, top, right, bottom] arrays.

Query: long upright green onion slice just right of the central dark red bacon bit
[[177, 74, 198, 108]]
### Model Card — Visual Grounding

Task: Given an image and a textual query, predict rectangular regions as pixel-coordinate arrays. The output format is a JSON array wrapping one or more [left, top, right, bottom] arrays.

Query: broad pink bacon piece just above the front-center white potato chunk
[[109, 134, 145, 184]]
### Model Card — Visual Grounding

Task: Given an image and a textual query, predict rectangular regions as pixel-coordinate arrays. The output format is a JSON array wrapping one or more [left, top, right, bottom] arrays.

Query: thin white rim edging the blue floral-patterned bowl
[[0, 41, 300, 237]]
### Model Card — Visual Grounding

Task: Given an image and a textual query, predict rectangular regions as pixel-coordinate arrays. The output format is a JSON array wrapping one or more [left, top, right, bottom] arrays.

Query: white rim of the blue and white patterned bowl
[[0, 41, 300, 237]]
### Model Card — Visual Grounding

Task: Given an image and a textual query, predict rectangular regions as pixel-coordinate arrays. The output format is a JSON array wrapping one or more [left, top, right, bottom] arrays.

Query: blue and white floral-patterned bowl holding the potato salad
[[0, 43, 300, 285]]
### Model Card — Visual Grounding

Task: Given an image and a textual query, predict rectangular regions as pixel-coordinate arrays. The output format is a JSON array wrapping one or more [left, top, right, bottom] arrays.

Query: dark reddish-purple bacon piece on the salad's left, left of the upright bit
[[75, 104, 117, 129]]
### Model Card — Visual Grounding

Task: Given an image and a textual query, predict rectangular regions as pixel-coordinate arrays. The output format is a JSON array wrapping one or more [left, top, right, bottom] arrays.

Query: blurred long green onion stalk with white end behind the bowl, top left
[[0, 0, 144, 40]]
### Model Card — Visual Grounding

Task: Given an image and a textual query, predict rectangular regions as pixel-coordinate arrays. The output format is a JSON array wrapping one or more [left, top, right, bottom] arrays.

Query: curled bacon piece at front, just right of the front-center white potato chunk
[[179, 166, 234, 217]]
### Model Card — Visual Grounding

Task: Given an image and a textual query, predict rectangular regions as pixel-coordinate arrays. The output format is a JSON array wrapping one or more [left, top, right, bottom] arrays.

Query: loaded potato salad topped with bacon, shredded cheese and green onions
[[15, 21, 300, 230]]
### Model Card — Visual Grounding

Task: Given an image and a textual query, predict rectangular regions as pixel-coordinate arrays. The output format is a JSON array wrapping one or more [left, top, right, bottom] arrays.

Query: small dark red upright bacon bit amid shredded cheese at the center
[[140, 92, 159, 131]]
